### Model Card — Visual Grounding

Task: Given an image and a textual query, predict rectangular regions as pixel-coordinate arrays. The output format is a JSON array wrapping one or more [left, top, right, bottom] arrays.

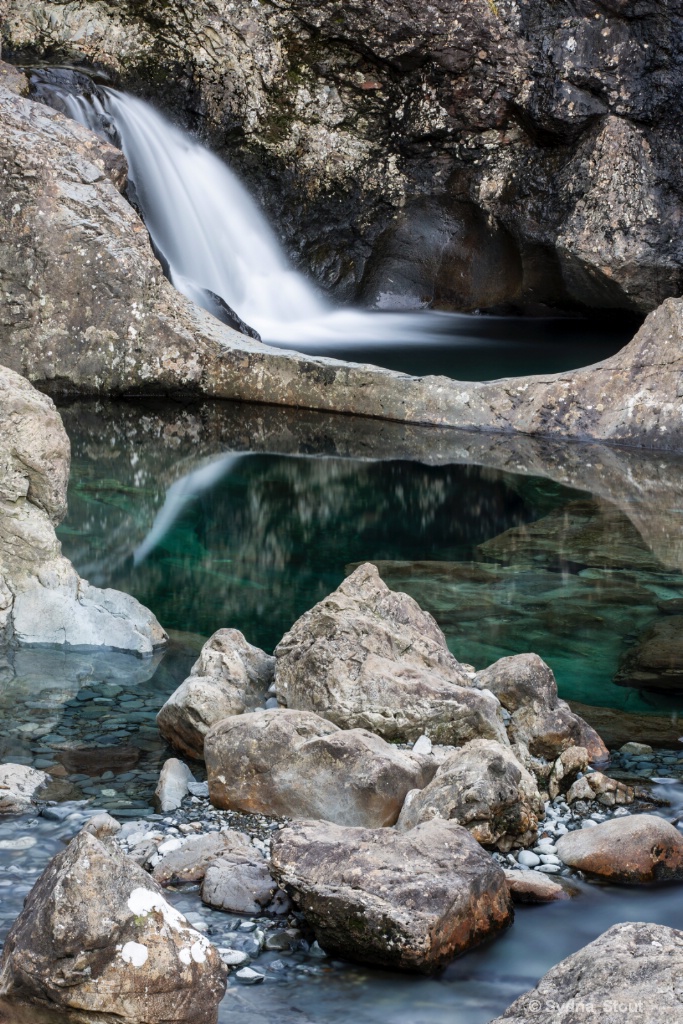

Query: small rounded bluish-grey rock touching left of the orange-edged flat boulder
[[202, 847, 278, 914]]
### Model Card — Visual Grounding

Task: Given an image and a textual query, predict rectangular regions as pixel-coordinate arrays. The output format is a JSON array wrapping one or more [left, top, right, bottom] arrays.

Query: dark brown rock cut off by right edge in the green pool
[[614, 615, 683, 693]]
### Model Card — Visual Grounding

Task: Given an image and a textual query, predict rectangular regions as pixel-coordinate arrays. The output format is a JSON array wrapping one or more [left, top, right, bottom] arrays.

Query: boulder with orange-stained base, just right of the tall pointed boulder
[[476, 654, 607, 761]]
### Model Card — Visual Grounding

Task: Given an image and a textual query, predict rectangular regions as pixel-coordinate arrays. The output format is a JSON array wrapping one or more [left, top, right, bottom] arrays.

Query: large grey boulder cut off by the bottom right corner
[[492, 923, 683, 1024]]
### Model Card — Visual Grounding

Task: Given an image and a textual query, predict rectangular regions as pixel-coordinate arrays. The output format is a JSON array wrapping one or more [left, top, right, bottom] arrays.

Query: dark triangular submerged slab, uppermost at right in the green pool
[[479, 500, 663, 572]]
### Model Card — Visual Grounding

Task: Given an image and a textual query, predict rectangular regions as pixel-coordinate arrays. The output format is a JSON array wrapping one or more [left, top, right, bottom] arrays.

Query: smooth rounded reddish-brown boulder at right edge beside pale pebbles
[[557, 814, 683, 884]]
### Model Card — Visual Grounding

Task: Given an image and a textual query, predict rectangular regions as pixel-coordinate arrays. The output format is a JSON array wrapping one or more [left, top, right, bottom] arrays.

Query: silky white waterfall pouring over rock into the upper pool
[[32, 69, 471, 354]]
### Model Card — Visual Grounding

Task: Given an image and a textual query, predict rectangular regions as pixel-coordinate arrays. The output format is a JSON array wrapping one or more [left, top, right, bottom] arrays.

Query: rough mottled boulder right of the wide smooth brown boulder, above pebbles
[[398, 739, 544, 852]]
